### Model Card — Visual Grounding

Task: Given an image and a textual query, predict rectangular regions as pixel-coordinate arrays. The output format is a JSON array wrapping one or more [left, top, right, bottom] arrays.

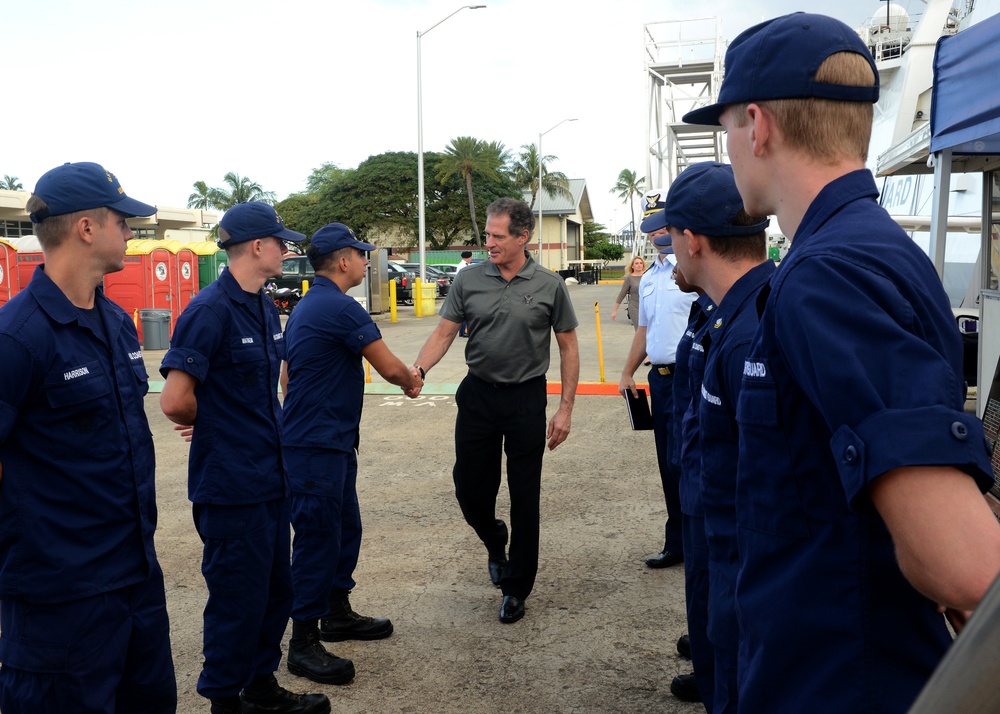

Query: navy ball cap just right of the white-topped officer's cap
[[653, 161, 770, 238]]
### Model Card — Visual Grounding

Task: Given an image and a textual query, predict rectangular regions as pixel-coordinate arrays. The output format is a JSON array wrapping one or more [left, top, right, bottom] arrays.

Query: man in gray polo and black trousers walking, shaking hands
[[412, 198, 580, 623]]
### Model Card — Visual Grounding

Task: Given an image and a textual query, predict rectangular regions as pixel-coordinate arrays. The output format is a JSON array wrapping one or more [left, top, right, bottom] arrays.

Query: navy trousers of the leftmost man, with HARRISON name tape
[[0, 565, 177, 714]]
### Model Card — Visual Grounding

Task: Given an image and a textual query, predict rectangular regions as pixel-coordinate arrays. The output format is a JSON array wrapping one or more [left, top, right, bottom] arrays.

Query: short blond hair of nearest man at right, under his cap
[[731, 52, 876, 163]]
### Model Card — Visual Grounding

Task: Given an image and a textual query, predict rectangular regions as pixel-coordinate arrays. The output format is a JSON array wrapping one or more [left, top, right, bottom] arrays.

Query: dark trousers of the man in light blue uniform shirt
[[649, 367, 684, 553]]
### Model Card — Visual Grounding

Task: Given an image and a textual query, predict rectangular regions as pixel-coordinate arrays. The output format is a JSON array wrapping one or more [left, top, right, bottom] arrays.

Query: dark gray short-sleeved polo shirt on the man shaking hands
[[441, 254, 579, 383]]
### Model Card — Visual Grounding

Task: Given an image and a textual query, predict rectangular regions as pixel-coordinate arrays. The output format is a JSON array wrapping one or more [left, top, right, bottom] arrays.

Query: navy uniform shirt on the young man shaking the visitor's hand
[[283, 276, 382, 452]]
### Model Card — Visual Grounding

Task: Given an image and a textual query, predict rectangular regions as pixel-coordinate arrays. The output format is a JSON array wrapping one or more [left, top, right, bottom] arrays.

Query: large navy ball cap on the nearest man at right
[[683, 12, 879, 126]]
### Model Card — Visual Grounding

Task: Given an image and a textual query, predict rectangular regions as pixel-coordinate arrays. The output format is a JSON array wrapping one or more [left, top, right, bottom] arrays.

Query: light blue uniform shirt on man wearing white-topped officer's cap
[[639, 254, 698, 364]]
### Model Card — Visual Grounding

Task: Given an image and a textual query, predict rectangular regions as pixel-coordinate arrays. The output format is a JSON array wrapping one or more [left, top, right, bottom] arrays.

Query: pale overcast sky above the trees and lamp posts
[[0, 0, 904, 227]]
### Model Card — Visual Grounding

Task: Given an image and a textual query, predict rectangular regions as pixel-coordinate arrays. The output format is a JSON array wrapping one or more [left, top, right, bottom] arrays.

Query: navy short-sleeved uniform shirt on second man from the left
[[160, 268, 285, 505]]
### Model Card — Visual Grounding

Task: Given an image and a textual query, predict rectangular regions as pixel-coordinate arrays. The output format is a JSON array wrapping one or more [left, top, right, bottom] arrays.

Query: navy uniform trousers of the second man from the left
[[194, 498, 292, 698]]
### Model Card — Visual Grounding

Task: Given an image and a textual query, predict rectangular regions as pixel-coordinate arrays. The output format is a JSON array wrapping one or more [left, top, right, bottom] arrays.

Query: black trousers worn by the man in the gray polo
[[452, 374, 546, 600]]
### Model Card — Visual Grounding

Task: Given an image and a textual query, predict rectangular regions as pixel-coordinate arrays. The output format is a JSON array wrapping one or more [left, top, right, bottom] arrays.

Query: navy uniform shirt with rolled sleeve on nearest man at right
[[736, 170, 992, 714]]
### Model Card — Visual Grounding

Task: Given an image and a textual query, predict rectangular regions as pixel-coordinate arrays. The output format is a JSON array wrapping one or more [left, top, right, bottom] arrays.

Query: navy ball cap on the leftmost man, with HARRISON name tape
[[31, 161, 156, 223]]
